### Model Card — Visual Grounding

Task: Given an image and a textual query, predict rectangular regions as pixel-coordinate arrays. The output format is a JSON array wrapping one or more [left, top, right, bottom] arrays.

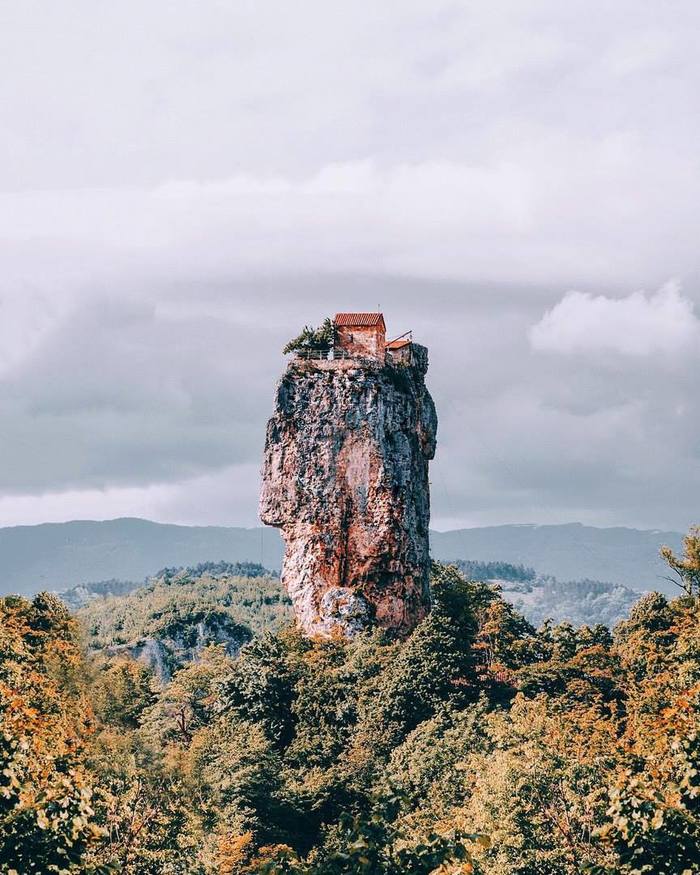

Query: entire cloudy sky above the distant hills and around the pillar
[[0, 0, 700, 529]]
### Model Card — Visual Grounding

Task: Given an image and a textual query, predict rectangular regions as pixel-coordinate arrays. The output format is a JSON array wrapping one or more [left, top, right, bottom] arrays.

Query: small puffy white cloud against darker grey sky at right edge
[[529, 281, 700, 356]]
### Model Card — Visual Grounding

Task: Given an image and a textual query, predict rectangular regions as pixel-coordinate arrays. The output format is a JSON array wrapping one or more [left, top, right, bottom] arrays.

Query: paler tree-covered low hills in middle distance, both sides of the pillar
[[74, 559, 640, 648]]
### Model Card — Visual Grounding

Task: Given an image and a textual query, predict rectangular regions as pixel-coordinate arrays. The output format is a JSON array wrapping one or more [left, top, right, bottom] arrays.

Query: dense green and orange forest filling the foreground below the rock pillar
[[0, 531, 700, 875]]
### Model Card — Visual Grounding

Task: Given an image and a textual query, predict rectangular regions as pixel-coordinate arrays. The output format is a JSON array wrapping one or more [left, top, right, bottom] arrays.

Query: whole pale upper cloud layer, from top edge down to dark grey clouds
[[0, 0, 700, 293]]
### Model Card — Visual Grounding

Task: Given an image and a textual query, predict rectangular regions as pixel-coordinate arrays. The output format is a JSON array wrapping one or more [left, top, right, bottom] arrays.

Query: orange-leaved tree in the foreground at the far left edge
[[0, 593, 100, 873]]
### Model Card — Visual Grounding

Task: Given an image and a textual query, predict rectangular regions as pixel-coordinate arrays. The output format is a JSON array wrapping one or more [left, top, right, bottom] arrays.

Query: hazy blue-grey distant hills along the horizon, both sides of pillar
[[0, 518, 682, 594]]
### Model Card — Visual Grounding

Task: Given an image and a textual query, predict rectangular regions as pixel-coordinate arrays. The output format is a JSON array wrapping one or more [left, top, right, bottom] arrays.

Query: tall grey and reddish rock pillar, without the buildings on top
[[260, 344, 437, 637]]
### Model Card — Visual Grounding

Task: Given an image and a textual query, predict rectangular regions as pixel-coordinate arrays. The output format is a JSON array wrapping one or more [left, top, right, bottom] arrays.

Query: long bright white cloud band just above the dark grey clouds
[[0, 144, 700, 296]]
